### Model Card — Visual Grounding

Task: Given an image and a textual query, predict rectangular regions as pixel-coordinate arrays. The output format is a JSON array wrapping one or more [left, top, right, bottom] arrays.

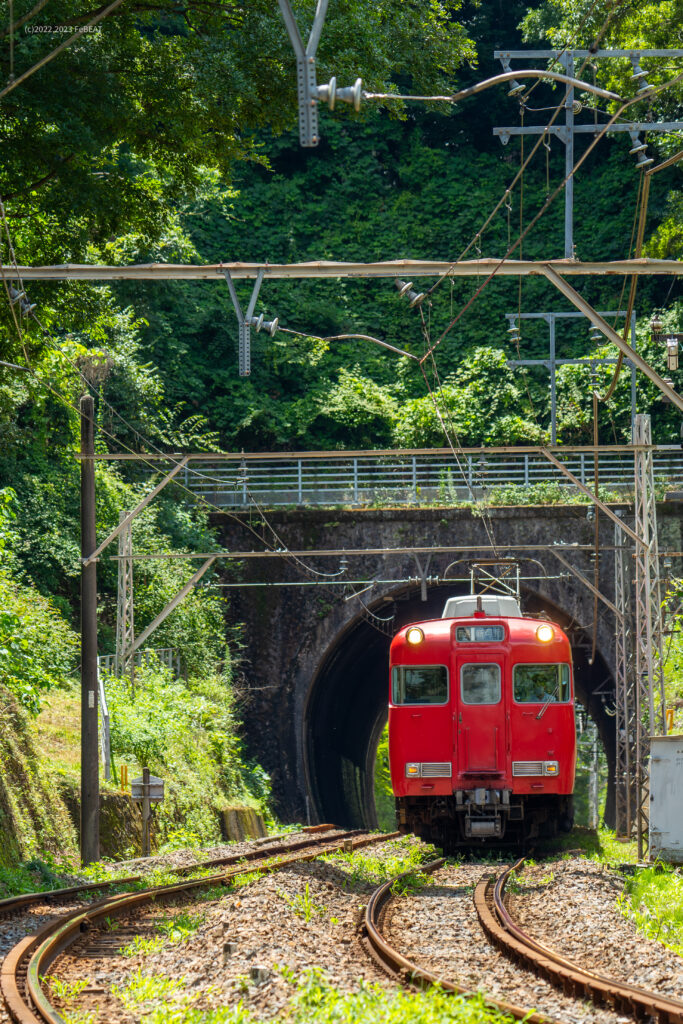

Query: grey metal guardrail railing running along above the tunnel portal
[[167, 444, 683, 508]]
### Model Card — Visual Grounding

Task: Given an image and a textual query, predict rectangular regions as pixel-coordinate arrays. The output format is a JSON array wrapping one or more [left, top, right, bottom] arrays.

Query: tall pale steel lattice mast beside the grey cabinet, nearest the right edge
[[633, 415, 667, 858]]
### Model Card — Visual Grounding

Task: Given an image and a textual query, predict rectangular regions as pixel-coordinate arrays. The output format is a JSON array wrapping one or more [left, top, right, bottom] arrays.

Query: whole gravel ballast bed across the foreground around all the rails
[[5, 836, 683, 1024]]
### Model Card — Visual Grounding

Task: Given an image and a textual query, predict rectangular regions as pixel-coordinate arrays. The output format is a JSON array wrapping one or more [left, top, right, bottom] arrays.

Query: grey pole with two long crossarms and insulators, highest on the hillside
[[494, 49, 683, 259]]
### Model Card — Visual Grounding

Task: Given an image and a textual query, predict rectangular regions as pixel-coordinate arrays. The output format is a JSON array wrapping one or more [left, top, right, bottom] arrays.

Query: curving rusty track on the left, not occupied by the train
[[0, 825, 398, 1024]]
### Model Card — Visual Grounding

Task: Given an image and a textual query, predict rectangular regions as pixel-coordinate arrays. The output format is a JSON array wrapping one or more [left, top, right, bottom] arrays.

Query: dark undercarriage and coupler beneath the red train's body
[[396, 787, 573, 853]]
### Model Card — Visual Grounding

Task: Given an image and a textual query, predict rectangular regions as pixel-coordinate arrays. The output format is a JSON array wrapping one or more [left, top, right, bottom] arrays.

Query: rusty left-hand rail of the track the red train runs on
[[361, 858, 553, 1024]]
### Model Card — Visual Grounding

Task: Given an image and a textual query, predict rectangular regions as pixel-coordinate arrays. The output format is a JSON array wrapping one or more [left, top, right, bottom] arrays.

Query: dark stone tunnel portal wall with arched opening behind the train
[[217, 502, 683, 825]]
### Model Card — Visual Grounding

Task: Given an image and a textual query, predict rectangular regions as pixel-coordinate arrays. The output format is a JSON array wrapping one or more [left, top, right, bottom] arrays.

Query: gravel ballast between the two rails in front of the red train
[[384, 863, 639, 1024]]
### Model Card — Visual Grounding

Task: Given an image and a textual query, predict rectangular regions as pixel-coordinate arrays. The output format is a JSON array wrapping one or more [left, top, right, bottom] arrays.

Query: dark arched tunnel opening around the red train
[[304, 586, 614, 827]]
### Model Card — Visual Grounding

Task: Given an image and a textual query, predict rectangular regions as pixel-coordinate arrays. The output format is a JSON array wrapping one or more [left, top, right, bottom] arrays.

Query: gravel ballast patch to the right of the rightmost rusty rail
[[508, 859, 683, 999]]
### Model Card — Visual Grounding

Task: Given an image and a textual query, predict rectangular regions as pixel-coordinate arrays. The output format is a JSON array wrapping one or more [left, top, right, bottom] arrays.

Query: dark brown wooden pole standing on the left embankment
[[81, 394, 99, 864]]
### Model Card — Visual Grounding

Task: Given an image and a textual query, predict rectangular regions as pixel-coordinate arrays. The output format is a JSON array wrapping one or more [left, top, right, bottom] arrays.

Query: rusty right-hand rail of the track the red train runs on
[[474, 857, 683, 1024]]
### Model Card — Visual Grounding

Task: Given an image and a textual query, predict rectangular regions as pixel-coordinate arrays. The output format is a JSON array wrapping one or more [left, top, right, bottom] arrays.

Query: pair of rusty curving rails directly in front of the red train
[[361, 858, 683, 1024]]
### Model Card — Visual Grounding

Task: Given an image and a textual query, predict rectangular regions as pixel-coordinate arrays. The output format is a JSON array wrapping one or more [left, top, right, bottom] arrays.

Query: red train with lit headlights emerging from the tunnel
[[389, 595, 575, 849]]
